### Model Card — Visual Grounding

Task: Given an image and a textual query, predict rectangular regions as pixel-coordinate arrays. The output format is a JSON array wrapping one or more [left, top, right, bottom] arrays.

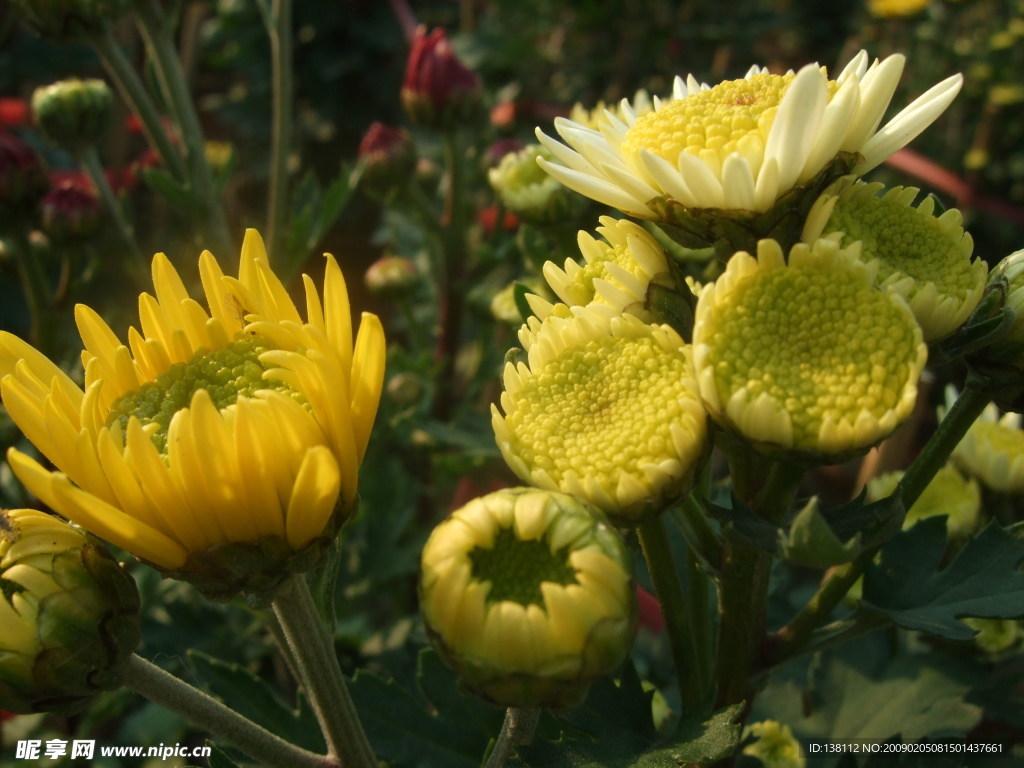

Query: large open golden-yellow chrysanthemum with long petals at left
[[0, 230, 384, 597]]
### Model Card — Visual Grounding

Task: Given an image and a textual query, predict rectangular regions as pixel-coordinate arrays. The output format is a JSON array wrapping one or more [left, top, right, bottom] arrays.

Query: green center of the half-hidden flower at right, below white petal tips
[[827, 197, 979, 298]]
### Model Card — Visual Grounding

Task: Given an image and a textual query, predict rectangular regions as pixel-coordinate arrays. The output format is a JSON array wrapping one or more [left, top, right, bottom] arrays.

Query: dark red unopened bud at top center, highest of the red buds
[[401, 27, 480, 128]]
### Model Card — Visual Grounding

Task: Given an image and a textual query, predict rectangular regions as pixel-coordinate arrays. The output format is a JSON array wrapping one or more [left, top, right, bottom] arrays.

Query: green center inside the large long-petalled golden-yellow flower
[[106, 336, 302, 453]]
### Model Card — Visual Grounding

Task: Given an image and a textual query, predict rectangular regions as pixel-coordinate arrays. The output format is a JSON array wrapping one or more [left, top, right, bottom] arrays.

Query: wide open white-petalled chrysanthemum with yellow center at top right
[[538, 51, 963, 219]]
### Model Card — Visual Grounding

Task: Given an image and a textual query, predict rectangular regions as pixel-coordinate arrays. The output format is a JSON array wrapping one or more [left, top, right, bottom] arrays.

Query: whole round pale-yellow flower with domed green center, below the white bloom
[[693, 240, 928, 459]]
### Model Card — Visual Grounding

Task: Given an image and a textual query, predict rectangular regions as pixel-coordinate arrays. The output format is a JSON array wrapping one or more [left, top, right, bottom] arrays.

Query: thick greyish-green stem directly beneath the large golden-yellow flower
[[272, 574, 377, 768]]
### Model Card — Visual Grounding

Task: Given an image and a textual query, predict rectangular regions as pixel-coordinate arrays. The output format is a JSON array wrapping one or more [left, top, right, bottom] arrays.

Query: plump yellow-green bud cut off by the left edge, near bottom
[[0, 509, 139, 715]]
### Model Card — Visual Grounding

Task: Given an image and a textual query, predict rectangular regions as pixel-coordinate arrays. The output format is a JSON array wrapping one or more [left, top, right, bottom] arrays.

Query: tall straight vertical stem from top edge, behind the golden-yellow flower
[[261, 0, 294, 264]]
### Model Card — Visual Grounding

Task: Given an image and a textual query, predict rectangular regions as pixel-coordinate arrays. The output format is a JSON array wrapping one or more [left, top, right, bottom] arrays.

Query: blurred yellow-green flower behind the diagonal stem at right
[[867, 464, 981, 540]]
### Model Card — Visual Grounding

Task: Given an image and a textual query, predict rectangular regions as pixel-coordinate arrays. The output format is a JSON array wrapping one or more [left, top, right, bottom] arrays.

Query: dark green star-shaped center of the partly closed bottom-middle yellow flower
[[469, 528, 577, 608]]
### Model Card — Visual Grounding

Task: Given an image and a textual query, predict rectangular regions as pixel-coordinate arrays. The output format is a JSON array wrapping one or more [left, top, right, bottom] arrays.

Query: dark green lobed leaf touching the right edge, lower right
[[864, 516, 1024, 640]]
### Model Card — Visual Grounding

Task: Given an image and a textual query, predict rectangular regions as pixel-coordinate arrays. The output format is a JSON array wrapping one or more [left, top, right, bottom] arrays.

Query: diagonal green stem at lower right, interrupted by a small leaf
[[771, 387, 990, 664]]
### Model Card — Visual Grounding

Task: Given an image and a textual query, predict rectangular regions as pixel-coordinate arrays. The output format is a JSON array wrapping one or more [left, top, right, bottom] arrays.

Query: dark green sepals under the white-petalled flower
[[647, 153, 861, 257]]
